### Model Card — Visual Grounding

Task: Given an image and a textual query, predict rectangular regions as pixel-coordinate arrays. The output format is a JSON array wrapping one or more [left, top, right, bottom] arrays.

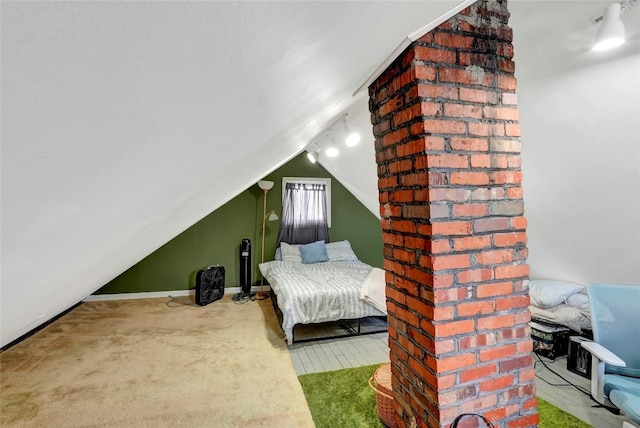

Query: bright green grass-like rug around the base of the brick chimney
[[298, 364, 590, 428]]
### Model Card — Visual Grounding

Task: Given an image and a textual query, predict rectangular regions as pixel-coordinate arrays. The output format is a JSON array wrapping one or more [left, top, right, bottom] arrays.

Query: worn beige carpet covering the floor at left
[[0, 295, 314, 428]]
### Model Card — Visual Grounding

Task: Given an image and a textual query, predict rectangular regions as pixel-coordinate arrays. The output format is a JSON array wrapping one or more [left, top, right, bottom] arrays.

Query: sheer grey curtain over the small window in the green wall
[[278, 183, 329, 246]]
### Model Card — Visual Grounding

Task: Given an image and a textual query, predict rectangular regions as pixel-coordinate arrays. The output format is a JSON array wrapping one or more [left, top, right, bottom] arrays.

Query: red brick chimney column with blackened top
[[369, 0, 538, 427]]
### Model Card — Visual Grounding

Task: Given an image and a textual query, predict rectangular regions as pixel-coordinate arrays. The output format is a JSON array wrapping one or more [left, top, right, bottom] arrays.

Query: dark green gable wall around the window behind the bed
[[94, 153, 383, 294]]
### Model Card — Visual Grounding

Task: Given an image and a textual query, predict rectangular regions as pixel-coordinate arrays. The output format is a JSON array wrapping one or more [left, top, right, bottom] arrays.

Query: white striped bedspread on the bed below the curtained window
[[260, 260, 384, 344]]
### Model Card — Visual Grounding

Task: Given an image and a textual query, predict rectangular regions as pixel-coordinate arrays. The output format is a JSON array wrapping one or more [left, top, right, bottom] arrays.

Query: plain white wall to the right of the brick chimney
[[511, 2, 640, 284]]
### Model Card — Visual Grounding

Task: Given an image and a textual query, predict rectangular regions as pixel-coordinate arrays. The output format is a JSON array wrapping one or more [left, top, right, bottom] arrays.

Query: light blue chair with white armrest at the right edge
[[581, 284, 640, 426]]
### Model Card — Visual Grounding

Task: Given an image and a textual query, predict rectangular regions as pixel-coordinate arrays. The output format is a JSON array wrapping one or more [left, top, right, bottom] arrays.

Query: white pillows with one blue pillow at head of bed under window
[[276, 240, 358, 264]]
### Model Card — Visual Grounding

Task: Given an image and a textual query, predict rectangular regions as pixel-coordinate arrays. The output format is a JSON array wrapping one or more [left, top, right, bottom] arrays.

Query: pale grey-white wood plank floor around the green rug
[[289, 333, 636, 428]]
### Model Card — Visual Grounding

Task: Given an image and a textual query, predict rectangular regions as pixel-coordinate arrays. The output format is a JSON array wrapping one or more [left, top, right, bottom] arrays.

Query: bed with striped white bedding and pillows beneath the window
[[259, 241, 386, 345]]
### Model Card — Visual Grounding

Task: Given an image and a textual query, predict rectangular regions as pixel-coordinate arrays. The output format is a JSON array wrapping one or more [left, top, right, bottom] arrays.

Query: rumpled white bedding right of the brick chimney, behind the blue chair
[[529, 280, 591, 334]]
